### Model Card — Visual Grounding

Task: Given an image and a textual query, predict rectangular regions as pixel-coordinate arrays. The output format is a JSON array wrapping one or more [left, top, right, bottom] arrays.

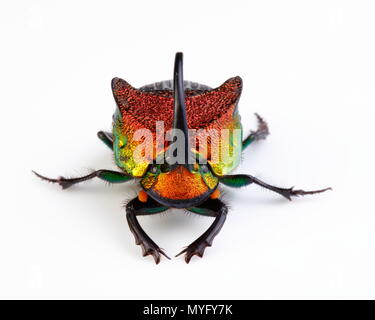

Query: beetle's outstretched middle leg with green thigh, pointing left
[[33, 170, 133, 189]]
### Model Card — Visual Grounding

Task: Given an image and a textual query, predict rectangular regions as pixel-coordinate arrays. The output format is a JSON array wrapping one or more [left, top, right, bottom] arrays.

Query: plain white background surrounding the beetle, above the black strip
[[0, 0, 375, 299]]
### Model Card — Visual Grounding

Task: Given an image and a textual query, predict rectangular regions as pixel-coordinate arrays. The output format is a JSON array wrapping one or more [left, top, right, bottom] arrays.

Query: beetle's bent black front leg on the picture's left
[[126, 198, 170, 264]]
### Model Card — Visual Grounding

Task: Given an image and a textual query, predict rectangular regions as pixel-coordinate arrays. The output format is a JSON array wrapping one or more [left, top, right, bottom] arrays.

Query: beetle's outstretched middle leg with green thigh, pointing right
[[220, 174, 332, 200]]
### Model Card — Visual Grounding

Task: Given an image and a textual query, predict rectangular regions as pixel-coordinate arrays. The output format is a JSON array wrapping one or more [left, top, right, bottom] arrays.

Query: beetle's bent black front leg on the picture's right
[[176, 199, 228, 263]]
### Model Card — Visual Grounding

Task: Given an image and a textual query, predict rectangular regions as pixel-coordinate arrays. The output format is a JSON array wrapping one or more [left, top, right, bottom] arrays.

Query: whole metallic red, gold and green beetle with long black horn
[[34, 53, 330, 263]]
